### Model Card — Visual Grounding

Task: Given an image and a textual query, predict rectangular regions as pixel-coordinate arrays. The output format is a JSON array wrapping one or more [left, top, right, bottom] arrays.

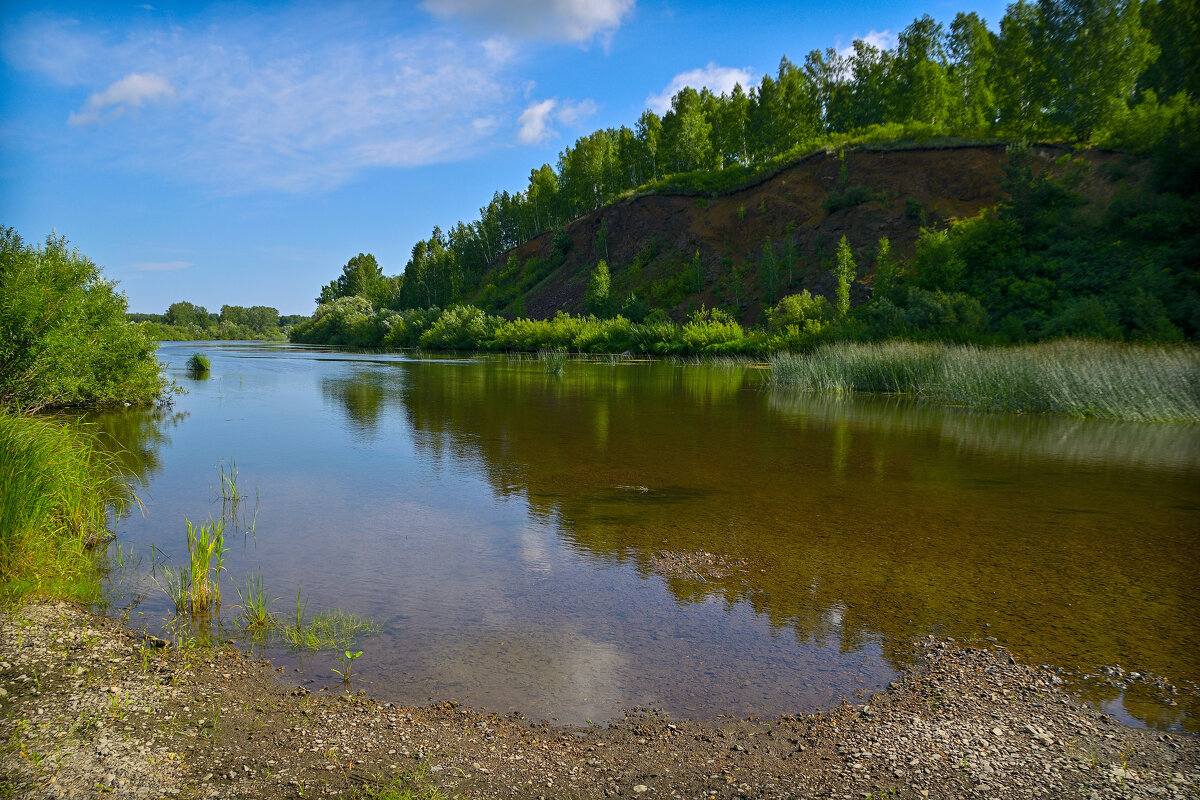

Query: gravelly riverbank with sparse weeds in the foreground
[[0, 603, 1200, 799]]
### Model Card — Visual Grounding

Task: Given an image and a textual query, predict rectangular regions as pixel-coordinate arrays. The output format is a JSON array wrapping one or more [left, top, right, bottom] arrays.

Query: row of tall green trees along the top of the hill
[[348, 0, 1200, 308]]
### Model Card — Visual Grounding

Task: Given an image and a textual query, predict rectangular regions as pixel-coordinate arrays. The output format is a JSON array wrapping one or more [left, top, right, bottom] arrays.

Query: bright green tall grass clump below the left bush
[[0, 413, 133, 604]]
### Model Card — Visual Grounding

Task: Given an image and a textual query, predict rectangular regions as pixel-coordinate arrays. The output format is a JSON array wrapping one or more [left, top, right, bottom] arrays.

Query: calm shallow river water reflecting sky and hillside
[[87, 343, 1200, 730]]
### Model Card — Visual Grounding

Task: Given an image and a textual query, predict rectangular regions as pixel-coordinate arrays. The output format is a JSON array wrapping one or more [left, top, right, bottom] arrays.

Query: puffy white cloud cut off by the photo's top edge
[[421, 0, 635, 42]]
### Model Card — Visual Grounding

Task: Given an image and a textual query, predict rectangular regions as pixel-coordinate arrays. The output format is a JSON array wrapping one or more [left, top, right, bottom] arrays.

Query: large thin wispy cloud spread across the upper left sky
[[4, 7, 520, 192]]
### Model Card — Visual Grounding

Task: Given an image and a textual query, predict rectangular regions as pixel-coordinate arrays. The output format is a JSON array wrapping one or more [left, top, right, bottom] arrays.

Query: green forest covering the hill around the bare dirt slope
[[293, 0, 1200, 350]]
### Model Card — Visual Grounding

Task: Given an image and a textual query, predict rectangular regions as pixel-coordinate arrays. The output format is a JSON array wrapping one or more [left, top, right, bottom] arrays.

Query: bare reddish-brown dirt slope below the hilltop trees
[[482, 145, 1120, 323]]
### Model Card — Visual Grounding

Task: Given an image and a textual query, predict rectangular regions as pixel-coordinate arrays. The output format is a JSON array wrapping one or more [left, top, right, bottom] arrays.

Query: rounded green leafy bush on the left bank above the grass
[[0, 228, 166, 411]]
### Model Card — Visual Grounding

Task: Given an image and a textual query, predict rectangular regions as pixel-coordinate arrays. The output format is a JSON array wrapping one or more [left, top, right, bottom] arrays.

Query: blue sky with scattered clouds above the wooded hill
[[0, 0, 1004, 314]]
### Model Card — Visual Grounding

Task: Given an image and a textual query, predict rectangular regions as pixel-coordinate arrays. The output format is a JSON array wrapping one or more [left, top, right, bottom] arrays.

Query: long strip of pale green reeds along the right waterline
[[770, 341, 1200, 423]]
